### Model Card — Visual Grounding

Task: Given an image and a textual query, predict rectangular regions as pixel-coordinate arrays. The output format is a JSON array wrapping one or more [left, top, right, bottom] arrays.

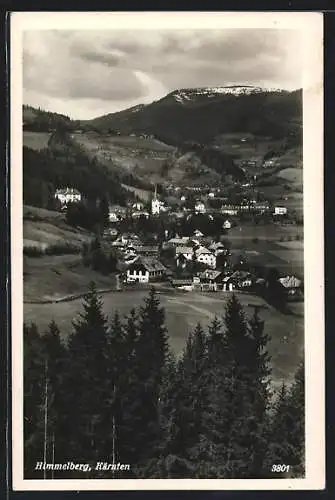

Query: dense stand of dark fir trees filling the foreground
[[23, 283, 304, 479]]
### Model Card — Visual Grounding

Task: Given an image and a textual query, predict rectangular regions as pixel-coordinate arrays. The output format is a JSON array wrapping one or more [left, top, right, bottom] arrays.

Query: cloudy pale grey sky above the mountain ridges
[[23, 29, 302, 119]]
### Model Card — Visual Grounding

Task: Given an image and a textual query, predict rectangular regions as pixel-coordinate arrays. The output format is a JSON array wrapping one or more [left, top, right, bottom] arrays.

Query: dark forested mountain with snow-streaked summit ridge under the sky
[[83, 86, 302, 146]]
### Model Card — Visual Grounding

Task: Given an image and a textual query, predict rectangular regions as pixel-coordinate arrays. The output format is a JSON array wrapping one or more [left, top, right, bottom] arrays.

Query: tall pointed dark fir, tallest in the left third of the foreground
[[65, 283, 110, 460]]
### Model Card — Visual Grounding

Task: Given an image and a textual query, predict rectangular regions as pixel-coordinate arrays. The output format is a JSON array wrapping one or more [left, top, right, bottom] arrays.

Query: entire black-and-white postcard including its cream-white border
[[11, 12, 324, 490]]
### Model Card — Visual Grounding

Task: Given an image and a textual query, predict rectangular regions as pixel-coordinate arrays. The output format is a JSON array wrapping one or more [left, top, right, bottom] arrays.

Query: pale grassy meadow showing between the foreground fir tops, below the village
[[24, 290, 304, 382]]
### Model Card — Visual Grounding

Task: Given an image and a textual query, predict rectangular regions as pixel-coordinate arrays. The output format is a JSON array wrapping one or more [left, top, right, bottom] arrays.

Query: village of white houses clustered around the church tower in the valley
[[55, 183, 303, 300]]
